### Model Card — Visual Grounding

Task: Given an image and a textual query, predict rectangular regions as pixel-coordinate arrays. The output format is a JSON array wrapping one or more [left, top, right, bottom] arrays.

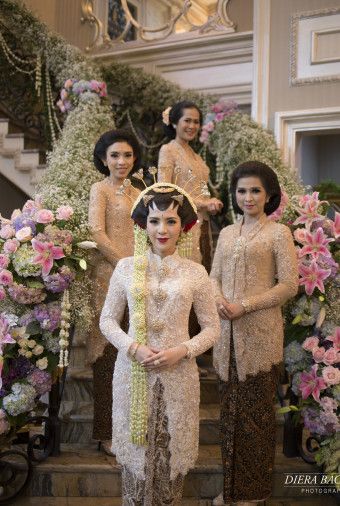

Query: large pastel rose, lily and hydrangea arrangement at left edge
[[0, 197, 86, 442]]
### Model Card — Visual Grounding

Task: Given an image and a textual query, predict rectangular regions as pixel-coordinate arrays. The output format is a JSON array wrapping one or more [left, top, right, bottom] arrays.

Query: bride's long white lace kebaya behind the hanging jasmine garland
[[100, 250, 220, 480]]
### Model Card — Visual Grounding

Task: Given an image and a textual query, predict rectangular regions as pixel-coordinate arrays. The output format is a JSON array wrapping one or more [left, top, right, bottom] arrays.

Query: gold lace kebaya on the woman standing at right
[[210, 215, 298, 381]]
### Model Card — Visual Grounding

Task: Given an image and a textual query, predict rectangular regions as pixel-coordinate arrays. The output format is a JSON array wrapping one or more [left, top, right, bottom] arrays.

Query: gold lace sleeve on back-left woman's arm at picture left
[[89, 183, 119, 266]]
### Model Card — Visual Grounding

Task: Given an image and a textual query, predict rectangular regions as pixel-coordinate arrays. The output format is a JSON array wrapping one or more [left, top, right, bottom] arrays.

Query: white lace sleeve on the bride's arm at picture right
[[183, 265, 220, 358]]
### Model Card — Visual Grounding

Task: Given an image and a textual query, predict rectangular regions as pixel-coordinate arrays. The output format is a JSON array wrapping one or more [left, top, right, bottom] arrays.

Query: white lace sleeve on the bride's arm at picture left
[[99, 259, 134, 353]]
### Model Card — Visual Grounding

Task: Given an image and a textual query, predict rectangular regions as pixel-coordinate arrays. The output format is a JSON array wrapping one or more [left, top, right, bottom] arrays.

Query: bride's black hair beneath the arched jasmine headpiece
[[131, 189, 197, 232]]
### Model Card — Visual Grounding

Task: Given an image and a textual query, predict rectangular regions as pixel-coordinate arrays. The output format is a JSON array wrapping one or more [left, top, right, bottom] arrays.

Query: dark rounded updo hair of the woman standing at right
[[230, 160, 281, 216]]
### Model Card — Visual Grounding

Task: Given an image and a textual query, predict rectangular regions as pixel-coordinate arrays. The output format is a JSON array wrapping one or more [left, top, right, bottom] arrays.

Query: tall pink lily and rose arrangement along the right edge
[[285, 192, 340, 482]]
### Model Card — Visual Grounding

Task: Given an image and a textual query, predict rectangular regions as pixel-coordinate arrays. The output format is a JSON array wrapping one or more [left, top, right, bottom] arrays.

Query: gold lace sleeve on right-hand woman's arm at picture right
[[242, 225, 299, 313]]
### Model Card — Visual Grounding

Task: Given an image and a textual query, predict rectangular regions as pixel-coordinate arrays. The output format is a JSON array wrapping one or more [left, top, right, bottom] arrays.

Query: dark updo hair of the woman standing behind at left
[[93, 130, 141, 176]]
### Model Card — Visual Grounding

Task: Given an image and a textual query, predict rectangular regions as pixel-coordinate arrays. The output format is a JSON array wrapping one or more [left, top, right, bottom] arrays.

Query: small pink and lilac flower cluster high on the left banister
[[57, 79, 107, 112]]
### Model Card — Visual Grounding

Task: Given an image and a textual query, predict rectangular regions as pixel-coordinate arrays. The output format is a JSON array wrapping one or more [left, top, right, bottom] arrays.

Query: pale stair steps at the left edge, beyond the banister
[[0, 118, 46, 197]]
